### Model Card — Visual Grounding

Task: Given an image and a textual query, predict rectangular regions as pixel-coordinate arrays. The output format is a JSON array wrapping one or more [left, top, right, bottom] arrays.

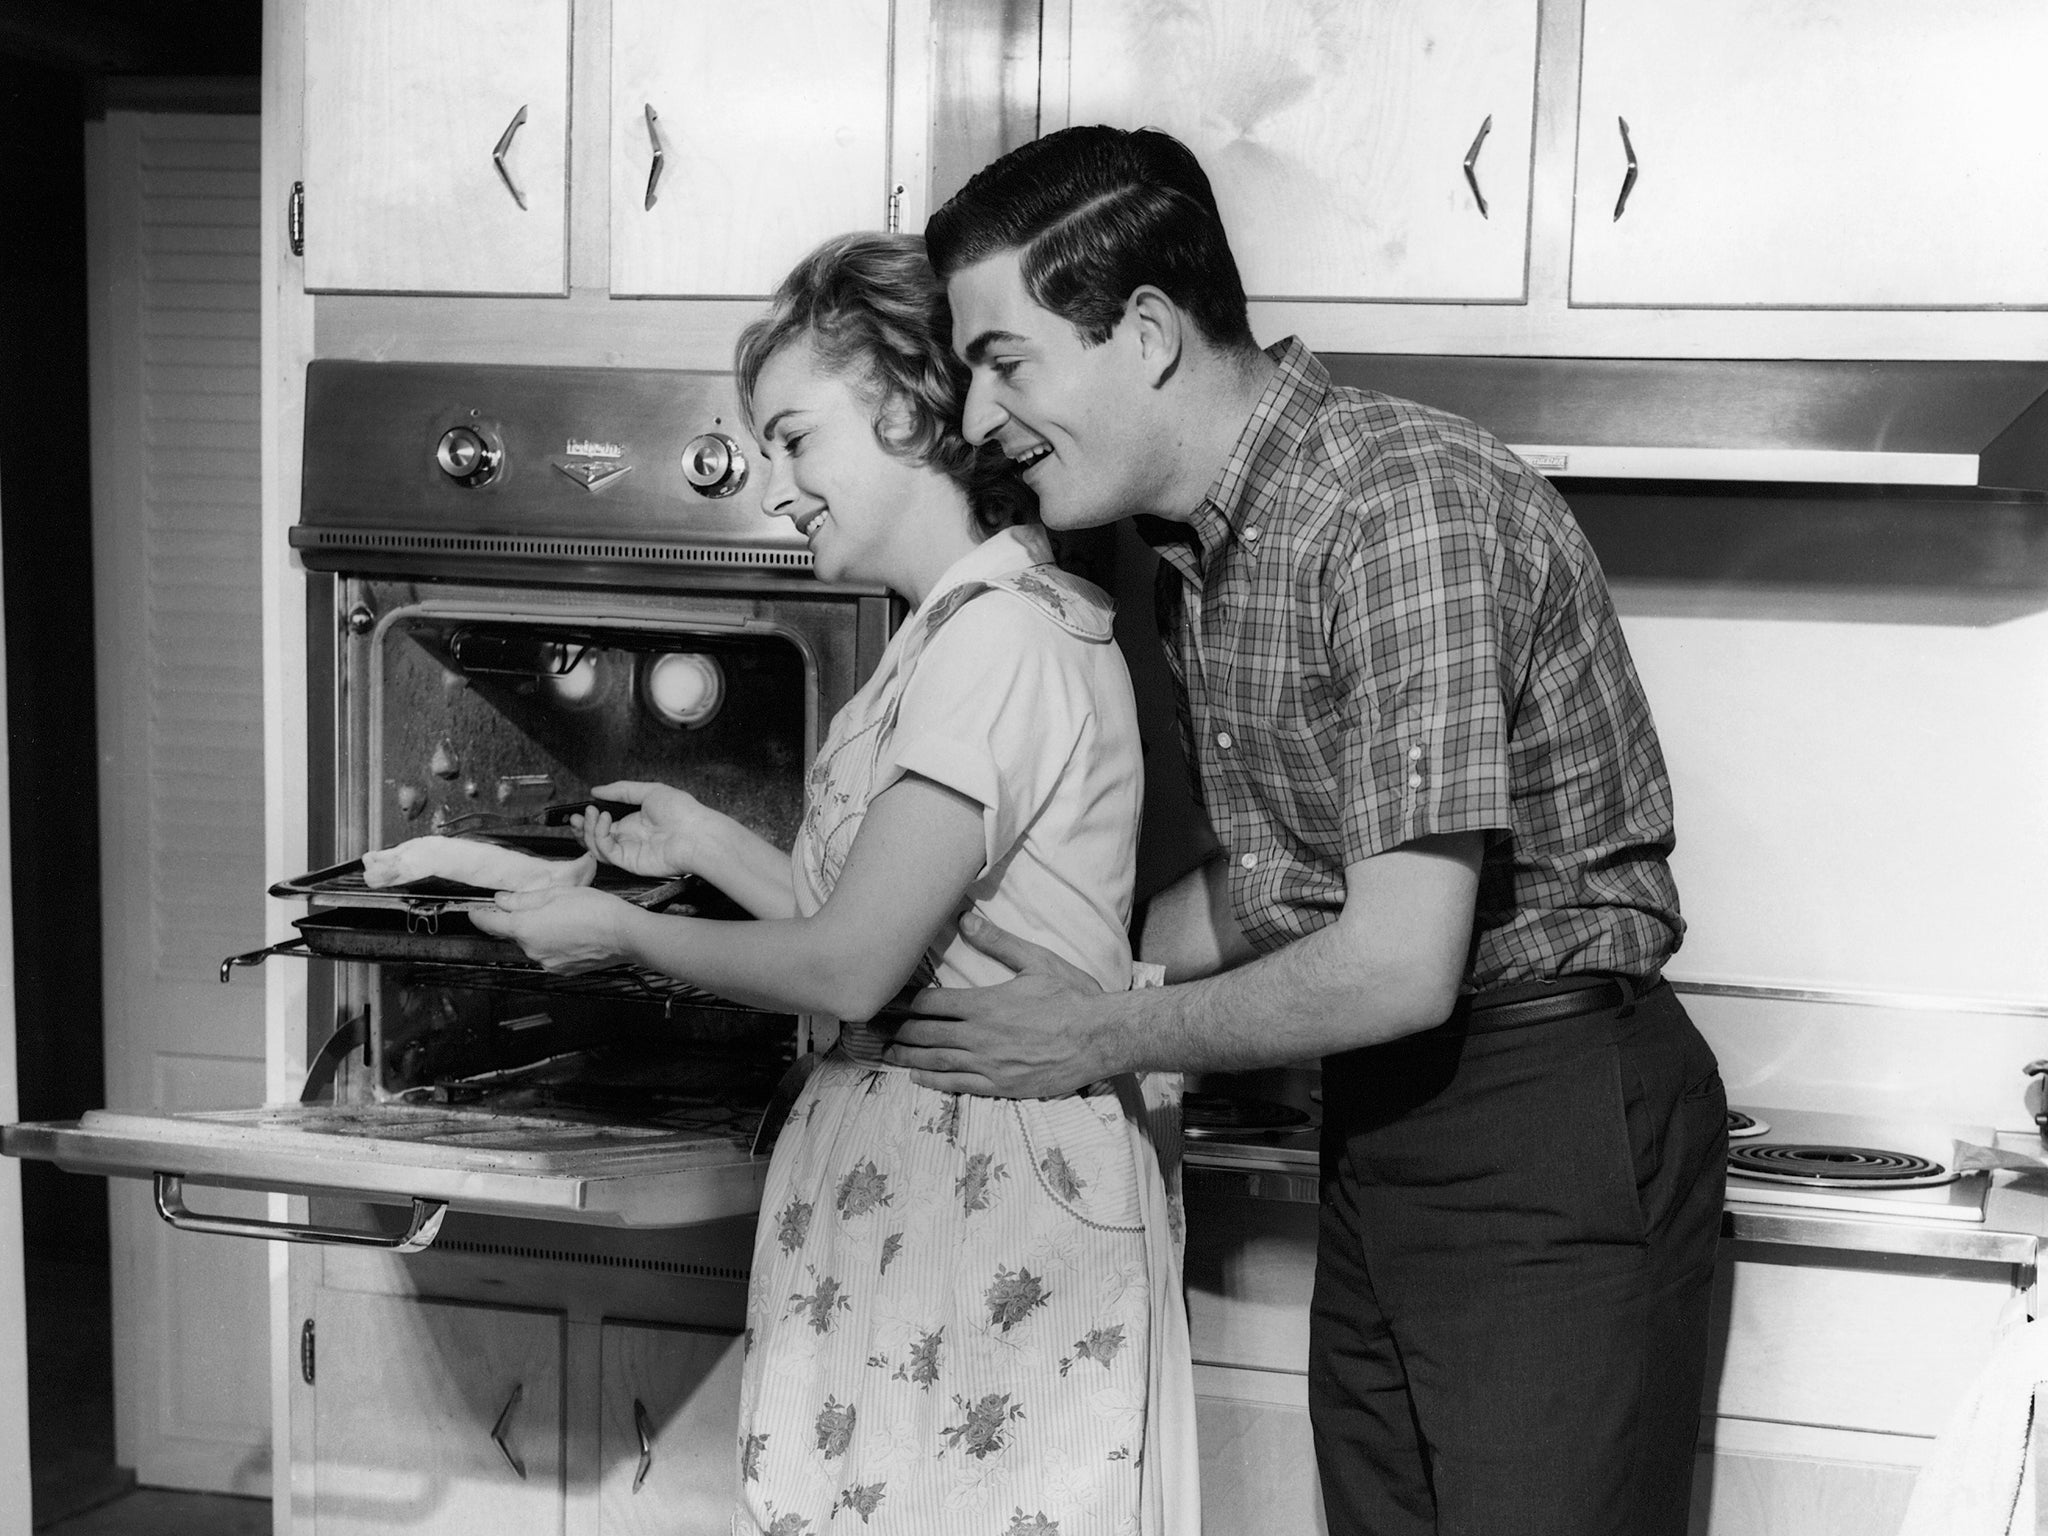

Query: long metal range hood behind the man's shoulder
[[1323, 352, 2048, 489]]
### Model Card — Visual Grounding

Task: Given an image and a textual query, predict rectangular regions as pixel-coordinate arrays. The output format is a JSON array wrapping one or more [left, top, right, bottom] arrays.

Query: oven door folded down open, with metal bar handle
[[0, 1104, 768, 1251]]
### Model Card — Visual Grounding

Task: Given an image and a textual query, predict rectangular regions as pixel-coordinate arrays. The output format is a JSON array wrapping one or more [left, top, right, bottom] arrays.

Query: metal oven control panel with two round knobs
[[291, 358, 811, 586]]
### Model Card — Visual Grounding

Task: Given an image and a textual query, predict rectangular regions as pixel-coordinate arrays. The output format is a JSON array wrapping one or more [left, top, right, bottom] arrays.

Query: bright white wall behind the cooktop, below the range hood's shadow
[[1616, 584, 2048, 1130]]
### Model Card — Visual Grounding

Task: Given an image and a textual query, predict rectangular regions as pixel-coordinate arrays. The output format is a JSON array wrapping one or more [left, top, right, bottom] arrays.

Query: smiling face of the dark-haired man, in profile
[[946, 250, 1157, 528]]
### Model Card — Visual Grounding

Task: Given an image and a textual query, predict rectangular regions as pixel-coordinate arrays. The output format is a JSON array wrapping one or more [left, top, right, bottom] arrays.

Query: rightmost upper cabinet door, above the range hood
[[1571, 0, 2048, 309]]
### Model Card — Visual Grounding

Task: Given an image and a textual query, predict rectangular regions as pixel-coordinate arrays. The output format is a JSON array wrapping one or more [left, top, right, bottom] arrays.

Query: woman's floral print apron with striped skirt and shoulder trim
[[733, 565, 1200, 1536]]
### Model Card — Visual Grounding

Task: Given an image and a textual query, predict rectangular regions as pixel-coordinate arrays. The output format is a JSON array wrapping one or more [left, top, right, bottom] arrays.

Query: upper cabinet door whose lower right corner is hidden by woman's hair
[[610, 0, 891, 297]]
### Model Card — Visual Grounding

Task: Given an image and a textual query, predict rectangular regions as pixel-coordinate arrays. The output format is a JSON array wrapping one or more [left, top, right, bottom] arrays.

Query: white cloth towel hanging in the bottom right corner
[[1898, 1323, 2048, 1536]]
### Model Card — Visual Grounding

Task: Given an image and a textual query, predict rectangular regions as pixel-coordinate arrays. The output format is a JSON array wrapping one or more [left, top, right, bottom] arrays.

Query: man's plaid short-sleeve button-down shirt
[[1147, 338, 1683, 989]]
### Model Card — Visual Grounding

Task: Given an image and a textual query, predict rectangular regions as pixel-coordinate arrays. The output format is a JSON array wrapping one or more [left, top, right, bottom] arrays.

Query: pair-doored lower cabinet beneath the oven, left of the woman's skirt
[[296, 1212, 752, 1536]]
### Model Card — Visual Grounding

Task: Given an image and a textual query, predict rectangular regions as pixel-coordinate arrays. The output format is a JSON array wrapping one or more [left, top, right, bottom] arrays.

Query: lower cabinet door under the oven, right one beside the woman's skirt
[[600, 1323, 745, 1536]]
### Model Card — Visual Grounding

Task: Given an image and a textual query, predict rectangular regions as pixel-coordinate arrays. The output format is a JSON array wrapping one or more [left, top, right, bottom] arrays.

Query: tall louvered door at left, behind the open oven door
[[88, 113, 270, 1493]]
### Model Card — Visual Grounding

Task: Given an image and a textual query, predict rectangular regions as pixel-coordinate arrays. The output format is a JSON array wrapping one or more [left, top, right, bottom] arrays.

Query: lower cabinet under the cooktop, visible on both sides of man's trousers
[[1186, 1167, 2025, 1536]]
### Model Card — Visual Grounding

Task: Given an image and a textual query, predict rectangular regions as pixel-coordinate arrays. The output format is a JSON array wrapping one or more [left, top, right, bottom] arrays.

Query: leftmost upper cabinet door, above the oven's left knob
[[305, 0, 569, 295]]
